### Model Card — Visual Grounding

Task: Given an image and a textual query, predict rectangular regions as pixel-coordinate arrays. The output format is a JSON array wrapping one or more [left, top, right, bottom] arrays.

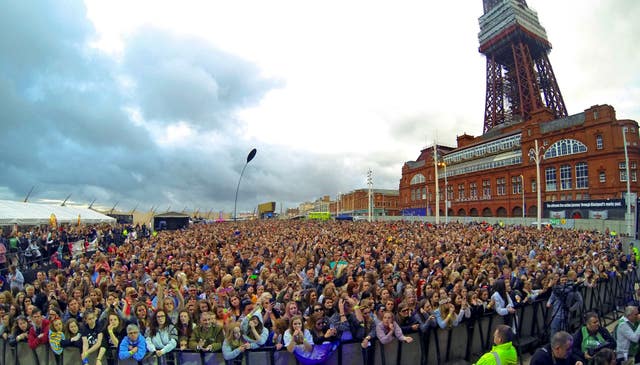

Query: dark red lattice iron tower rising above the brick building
[[478, 0, 567, 133]]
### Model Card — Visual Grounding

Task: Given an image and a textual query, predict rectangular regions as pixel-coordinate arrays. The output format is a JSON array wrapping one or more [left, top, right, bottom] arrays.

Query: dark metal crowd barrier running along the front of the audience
[[0, 272, 637, 365]]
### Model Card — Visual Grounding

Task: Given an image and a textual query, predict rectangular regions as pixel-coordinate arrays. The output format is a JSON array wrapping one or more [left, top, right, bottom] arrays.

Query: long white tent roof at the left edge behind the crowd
[[0, 200, 116, 225]]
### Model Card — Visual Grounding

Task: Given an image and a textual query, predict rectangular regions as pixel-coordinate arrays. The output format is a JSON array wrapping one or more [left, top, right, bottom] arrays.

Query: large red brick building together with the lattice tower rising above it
[[399, 0, 640, 227]]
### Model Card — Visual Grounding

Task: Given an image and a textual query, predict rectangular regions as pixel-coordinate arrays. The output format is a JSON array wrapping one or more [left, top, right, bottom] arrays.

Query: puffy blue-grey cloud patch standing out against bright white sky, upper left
[[123, 28, 278, 129]]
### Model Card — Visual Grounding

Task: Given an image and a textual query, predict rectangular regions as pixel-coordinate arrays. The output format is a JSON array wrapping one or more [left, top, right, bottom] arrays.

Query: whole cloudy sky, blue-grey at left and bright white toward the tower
[[0, 0, 640, 212]]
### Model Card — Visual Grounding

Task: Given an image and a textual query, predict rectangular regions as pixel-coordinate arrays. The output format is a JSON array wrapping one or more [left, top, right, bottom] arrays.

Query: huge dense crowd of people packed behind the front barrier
[[0, 220, 637, 365]]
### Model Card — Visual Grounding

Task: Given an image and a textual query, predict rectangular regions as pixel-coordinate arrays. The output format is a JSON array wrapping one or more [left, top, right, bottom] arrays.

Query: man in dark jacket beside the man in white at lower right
[[573, 312, 616, 362]]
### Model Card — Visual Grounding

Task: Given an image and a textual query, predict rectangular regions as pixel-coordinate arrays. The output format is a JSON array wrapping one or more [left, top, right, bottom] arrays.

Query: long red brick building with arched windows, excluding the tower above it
[[400, 105, 640, 218]]
